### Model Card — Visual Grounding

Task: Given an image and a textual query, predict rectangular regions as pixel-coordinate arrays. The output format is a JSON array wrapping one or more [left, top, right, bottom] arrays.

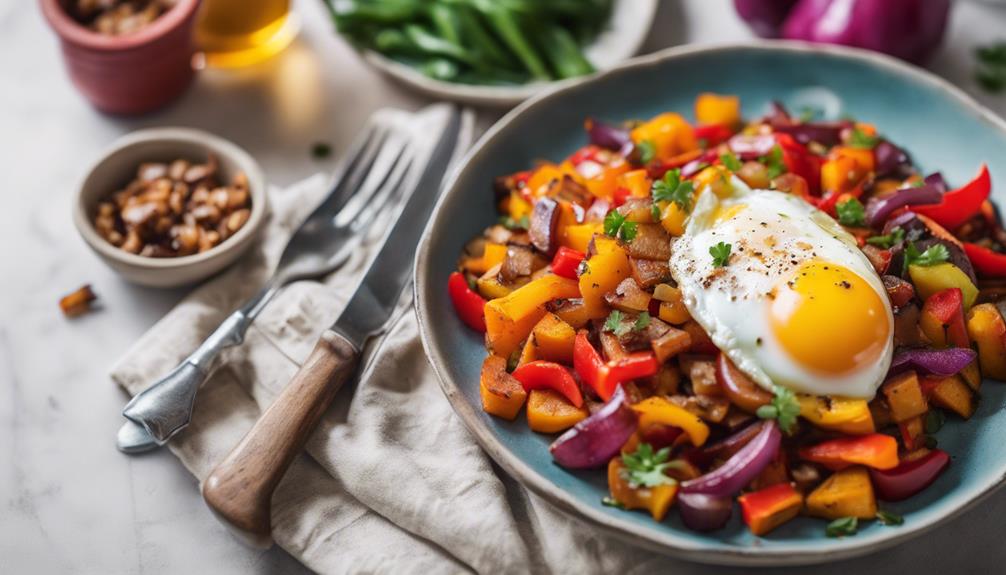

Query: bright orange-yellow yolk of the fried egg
[[769, 260, 891, 375]]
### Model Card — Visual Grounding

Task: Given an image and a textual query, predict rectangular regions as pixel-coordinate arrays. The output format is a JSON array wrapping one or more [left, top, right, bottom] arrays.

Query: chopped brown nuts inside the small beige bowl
[[95, 156, 252, 257]]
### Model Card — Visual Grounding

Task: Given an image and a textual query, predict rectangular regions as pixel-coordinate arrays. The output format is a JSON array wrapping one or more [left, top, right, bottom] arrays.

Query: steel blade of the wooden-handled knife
[[331, 108, 462, 351]]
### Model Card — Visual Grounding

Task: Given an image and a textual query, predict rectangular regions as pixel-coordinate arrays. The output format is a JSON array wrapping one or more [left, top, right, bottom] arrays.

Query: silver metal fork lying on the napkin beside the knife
[[117, 112, 414, 453]]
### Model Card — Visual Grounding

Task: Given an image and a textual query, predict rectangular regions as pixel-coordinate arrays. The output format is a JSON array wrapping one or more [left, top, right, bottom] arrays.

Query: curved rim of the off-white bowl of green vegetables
[[358, 0, 659, 107]]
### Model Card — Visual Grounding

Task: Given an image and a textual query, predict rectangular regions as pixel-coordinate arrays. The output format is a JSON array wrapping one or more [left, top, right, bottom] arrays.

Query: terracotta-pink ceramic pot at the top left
[[40, 0, 199, 115]]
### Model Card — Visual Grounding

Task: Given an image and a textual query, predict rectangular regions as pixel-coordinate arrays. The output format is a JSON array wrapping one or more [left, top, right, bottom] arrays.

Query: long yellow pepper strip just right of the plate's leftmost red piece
[[486, 273, 579, 357]]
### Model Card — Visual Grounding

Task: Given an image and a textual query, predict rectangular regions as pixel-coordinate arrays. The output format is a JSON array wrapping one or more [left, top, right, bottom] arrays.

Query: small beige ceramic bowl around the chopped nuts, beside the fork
[[73, 128, 269, 288]]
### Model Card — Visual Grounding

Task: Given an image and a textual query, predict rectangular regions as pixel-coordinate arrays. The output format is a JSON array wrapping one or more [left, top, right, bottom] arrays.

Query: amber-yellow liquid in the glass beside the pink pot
[[195, 0, 298, 67]]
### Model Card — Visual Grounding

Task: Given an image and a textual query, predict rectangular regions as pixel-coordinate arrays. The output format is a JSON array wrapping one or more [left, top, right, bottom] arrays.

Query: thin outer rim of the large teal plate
[[413, 40, 1006, 566]]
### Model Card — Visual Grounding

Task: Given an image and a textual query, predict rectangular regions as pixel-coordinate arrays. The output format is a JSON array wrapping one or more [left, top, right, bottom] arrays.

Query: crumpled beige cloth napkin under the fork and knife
[[112, 119, 701, 573]]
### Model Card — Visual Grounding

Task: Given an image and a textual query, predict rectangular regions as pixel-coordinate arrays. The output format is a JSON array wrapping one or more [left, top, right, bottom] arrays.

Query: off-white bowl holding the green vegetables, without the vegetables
[[363, 0, 657, 108]]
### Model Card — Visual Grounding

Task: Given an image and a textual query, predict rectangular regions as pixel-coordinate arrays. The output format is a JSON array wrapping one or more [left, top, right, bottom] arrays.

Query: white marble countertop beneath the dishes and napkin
[[0, 0, 1006, 574]]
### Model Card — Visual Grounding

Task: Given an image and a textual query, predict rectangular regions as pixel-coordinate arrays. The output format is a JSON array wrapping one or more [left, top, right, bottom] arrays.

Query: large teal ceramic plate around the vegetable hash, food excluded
[[415, 42, 1006, 565]]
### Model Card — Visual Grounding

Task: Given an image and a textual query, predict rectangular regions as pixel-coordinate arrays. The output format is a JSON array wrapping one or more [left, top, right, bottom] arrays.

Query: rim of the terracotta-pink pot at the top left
[[39, 0, 200, 52]]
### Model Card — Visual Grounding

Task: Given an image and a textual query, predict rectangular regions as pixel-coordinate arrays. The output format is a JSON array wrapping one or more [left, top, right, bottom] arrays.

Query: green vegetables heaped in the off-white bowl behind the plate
[[325, 0, 613, 84]]
